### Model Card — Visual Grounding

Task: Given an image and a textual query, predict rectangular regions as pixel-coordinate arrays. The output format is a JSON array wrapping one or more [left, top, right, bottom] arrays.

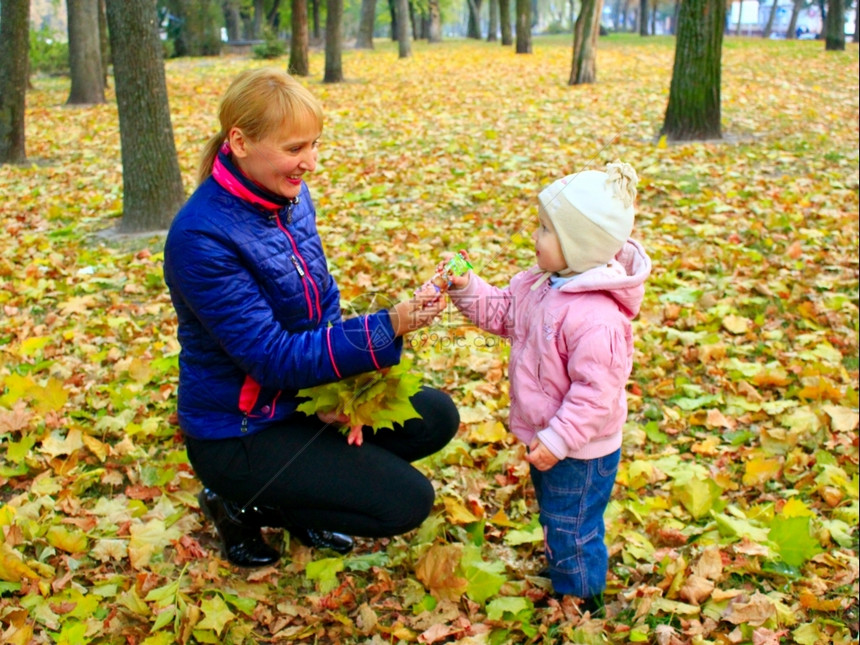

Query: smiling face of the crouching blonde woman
[[228, 118, 321, 199]]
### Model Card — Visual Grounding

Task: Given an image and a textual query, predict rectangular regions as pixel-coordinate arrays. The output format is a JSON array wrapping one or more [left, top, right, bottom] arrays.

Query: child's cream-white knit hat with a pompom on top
[[538, 161, 639, 273]]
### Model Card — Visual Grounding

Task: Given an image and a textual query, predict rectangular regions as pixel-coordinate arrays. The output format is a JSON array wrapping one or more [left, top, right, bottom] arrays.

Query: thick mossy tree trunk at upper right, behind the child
[[661, 0, 726, 141]]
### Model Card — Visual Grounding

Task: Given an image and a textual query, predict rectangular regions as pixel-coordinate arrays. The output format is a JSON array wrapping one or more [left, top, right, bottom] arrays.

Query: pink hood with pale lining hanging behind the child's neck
[[560, 239, 651, 319]]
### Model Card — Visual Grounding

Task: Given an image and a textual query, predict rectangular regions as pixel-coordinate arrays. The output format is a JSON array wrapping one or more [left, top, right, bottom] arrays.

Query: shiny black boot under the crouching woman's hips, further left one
[[197, 488, 281, 567]]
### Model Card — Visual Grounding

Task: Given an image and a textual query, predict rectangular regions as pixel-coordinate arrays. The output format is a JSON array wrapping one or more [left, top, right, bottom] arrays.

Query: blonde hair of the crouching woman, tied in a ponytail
[[197, 67, 323, 184]]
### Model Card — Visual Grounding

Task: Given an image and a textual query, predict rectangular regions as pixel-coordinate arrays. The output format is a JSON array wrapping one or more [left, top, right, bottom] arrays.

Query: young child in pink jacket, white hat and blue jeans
[[448, 162, 651, 615]]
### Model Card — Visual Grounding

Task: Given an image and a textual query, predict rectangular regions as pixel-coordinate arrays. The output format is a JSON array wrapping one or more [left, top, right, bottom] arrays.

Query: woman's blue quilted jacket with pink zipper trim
[[164, 177, 402, 439]]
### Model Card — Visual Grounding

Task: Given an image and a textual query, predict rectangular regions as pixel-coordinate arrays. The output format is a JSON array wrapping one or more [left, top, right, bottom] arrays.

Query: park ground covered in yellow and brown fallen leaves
[[0, 36, 860, 645]]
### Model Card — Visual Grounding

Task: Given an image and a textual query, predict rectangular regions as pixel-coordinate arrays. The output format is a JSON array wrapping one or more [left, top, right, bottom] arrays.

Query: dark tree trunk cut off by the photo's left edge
[[0, 0, 30, 164]]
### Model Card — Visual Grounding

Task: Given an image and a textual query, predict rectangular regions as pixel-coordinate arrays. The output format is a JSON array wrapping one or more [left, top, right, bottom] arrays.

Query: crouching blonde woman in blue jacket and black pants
[[164, 69, 459, 567]]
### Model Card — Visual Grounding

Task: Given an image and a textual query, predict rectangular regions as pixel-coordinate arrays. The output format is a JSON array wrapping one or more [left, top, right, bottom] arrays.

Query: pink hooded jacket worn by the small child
[[449, 240, 651, 459]]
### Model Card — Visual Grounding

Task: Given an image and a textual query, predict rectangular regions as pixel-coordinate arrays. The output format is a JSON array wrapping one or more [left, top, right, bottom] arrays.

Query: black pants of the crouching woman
[[186, 387, 460, 537]]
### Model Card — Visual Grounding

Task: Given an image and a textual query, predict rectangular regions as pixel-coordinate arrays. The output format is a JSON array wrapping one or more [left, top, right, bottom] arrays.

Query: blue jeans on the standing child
[[531, 450, 621, 598]]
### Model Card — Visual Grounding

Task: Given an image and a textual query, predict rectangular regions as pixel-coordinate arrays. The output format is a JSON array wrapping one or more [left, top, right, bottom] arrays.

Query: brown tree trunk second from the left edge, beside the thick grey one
[[66, 0, 105, 105]]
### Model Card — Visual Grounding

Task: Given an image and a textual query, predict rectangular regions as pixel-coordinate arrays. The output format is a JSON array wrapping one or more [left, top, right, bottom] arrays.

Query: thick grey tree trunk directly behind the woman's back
[[107, 0, 185, 233]]
